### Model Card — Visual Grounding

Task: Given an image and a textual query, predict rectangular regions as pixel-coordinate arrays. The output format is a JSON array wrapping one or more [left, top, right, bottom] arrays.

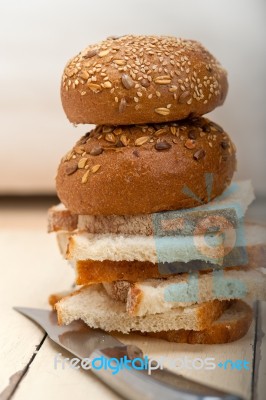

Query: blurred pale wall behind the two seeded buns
[[0, 0, 266, 203]]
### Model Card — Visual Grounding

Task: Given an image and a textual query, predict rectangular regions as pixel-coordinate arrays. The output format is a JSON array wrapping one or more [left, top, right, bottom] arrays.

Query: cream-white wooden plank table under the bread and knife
[[0, 203, 266, 400]]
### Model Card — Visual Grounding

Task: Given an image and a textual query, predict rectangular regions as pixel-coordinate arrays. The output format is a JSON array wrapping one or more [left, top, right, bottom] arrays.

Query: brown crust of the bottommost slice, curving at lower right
[[138, 300, 252, 344]]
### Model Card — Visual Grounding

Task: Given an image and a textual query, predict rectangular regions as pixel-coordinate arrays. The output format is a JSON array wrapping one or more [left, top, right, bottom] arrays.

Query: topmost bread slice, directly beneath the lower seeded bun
[[48, 181, 254, 236]]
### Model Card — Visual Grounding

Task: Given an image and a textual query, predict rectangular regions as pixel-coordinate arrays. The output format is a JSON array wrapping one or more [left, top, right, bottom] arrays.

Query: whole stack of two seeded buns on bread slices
[[49, 36, 266, 343]]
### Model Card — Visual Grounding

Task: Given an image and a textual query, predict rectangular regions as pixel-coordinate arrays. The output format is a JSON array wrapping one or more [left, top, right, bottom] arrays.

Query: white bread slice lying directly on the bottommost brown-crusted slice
[[55, 285, 230, 333]]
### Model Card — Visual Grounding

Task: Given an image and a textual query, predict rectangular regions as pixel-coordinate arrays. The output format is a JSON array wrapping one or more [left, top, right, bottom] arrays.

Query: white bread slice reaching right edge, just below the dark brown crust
[[103, 268, 266, 316]]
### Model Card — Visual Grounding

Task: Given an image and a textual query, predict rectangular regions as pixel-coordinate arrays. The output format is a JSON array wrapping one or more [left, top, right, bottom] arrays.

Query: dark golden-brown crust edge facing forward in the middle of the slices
[[76, 260, 249, 285]]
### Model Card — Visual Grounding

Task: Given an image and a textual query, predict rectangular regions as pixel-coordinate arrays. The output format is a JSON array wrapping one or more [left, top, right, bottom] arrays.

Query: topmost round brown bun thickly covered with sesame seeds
[[61, 36, 228, 125]]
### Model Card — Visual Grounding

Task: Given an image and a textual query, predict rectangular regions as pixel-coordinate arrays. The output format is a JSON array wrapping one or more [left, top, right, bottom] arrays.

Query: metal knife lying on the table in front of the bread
[[14, 307, 243, 400]]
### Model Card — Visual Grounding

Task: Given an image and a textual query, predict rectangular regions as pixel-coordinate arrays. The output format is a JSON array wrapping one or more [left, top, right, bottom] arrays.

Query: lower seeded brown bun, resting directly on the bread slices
[[56, 117, 236, 215]]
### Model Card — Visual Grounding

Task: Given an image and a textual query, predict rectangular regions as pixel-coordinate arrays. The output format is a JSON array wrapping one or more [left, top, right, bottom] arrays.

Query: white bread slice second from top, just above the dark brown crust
[[57, 223, 266, 266]]
